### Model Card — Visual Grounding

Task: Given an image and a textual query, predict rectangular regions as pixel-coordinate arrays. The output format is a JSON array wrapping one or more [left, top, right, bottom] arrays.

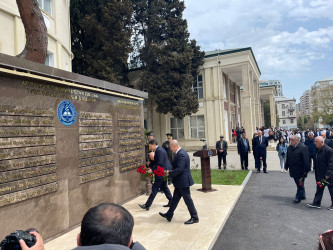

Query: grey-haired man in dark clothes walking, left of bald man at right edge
[[284, 135, 310, 203]]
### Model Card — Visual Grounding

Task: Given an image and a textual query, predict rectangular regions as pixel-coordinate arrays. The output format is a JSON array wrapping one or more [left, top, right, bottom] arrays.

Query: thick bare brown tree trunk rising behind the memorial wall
[[16, 0, 48, 64]]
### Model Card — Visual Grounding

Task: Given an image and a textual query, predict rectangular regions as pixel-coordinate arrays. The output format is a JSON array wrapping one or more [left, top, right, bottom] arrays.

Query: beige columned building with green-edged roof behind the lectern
[[153, 48, 276, 150]]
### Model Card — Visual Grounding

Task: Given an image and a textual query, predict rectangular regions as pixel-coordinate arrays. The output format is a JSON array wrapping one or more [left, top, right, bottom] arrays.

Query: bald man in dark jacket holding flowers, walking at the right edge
[[307, 136, 333, 210]]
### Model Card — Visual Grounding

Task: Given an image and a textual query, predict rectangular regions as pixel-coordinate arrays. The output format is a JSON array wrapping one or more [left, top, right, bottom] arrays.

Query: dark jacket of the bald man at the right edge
[[314, 144, 333, 185]]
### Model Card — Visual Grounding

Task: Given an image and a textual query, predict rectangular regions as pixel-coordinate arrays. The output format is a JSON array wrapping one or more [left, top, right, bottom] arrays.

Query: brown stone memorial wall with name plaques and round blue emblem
[[0, 54, 147, 240]]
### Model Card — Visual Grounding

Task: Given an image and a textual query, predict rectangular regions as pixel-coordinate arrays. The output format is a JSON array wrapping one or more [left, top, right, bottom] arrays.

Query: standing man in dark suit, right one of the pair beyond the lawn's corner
[[252, 130, 268, 174]]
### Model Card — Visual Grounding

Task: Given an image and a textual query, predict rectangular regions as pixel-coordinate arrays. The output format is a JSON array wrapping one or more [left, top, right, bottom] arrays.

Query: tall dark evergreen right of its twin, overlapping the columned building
[[133, 0, 204, 127]]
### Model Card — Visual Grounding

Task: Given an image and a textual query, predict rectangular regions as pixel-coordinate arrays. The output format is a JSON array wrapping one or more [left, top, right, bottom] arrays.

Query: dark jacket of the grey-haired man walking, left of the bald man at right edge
[[284, 142, 310, 179]]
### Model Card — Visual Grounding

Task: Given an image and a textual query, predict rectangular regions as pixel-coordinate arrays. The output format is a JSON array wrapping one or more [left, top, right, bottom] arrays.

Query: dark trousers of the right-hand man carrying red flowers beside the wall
[[167, 187, 198, 219]]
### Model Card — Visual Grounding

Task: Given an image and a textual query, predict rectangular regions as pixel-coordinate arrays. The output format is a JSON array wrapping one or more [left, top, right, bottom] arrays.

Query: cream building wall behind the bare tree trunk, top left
[[0, 0, 72, 71]]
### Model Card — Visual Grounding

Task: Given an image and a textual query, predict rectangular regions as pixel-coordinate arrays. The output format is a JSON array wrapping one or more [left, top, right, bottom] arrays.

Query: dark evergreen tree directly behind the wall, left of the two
[[70, 0, 133, 85]]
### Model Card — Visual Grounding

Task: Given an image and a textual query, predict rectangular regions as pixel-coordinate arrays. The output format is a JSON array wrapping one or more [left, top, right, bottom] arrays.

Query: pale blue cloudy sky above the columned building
[[183, 0, 333, 103]]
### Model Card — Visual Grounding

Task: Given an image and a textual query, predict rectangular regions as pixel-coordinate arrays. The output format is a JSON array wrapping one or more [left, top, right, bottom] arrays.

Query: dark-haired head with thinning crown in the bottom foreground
[[77, 203, 134, 247]]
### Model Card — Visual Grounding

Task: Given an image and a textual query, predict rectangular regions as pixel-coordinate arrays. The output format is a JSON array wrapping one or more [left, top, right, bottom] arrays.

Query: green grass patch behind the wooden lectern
[[191, 169, 249, 185]]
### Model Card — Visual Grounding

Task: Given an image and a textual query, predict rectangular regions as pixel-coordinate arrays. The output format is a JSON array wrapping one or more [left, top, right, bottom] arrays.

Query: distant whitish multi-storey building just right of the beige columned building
[[275, 97, 297, 129]]
